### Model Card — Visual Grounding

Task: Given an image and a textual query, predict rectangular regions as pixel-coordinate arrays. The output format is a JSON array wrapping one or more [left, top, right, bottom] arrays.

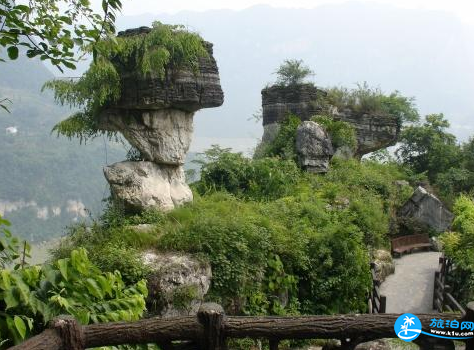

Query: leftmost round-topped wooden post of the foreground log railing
[[49, 315, 85, 350]]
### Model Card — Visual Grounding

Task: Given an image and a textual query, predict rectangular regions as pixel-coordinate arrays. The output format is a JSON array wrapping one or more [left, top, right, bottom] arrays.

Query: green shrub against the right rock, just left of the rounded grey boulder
[[259, 114, 301, 162]]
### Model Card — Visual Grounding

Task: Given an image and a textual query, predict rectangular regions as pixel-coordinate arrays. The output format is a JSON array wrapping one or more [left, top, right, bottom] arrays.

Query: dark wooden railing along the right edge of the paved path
[[433, 255, 466, 315]]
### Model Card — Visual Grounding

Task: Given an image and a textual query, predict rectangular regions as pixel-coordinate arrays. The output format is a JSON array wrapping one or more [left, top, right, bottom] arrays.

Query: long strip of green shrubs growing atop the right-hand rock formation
[[325, 82, 419, 124]]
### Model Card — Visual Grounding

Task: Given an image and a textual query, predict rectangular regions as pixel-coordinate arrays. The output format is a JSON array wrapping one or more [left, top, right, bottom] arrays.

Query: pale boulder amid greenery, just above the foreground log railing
[[142, 251, 212, 317]]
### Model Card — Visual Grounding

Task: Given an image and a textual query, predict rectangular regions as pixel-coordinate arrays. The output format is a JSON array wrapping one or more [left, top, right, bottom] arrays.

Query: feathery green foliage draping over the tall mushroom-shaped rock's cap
[[43, 22, 208, 141]]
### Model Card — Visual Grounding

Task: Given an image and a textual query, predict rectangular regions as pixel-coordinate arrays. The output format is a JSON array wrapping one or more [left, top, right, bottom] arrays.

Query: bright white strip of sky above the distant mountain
[[115, 0, 474, 24]]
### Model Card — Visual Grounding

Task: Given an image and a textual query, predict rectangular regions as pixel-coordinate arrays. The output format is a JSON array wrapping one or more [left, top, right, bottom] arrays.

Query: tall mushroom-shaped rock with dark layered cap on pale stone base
[[97, 27, 224, 212]]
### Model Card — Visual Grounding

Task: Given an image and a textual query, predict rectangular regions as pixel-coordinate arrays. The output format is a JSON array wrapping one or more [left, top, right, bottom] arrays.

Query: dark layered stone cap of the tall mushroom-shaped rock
[[113, 27, 224, 112]]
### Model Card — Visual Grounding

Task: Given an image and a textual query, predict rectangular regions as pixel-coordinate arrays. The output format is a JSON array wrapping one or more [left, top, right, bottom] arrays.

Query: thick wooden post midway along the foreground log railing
[[197, 303, 226, 350]]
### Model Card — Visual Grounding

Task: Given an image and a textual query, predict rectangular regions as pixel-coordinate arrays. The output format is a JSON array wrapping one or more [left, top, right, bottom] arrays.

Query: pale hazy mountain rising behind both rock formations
[[118, 2, 474, 142]]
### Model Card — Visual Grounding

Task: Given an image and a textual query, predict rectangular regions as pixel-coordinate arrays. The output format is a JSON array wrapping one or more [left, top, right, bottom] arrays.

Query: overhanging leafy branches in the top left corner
[[0, 0, 122, 71]]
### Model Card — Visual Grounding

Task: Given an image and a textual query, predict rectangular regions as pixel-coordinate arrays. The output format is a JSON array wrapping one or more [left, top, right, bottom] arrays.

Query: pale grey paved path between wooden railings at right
[[381, 252, 440, 314]]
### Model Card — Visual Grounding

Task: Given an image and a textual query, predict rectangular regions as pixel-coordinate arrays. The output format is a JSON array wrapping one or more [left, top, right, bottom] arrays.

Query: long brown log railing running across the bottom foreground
[[10, 303, 474, 350]]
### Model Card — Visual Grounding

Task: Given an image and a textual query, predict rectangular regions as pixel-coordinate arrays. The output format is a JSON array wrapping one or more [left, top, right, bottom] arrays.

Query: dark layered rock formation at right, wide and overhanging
[[262, 84, 400, 158]]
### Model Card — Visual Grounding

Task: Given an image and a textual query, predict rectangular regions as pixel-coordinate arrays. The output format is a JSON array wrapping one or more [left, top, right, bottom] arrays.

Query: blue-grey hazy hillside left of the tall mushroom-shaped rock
[[0, 58, 125, 241]]
